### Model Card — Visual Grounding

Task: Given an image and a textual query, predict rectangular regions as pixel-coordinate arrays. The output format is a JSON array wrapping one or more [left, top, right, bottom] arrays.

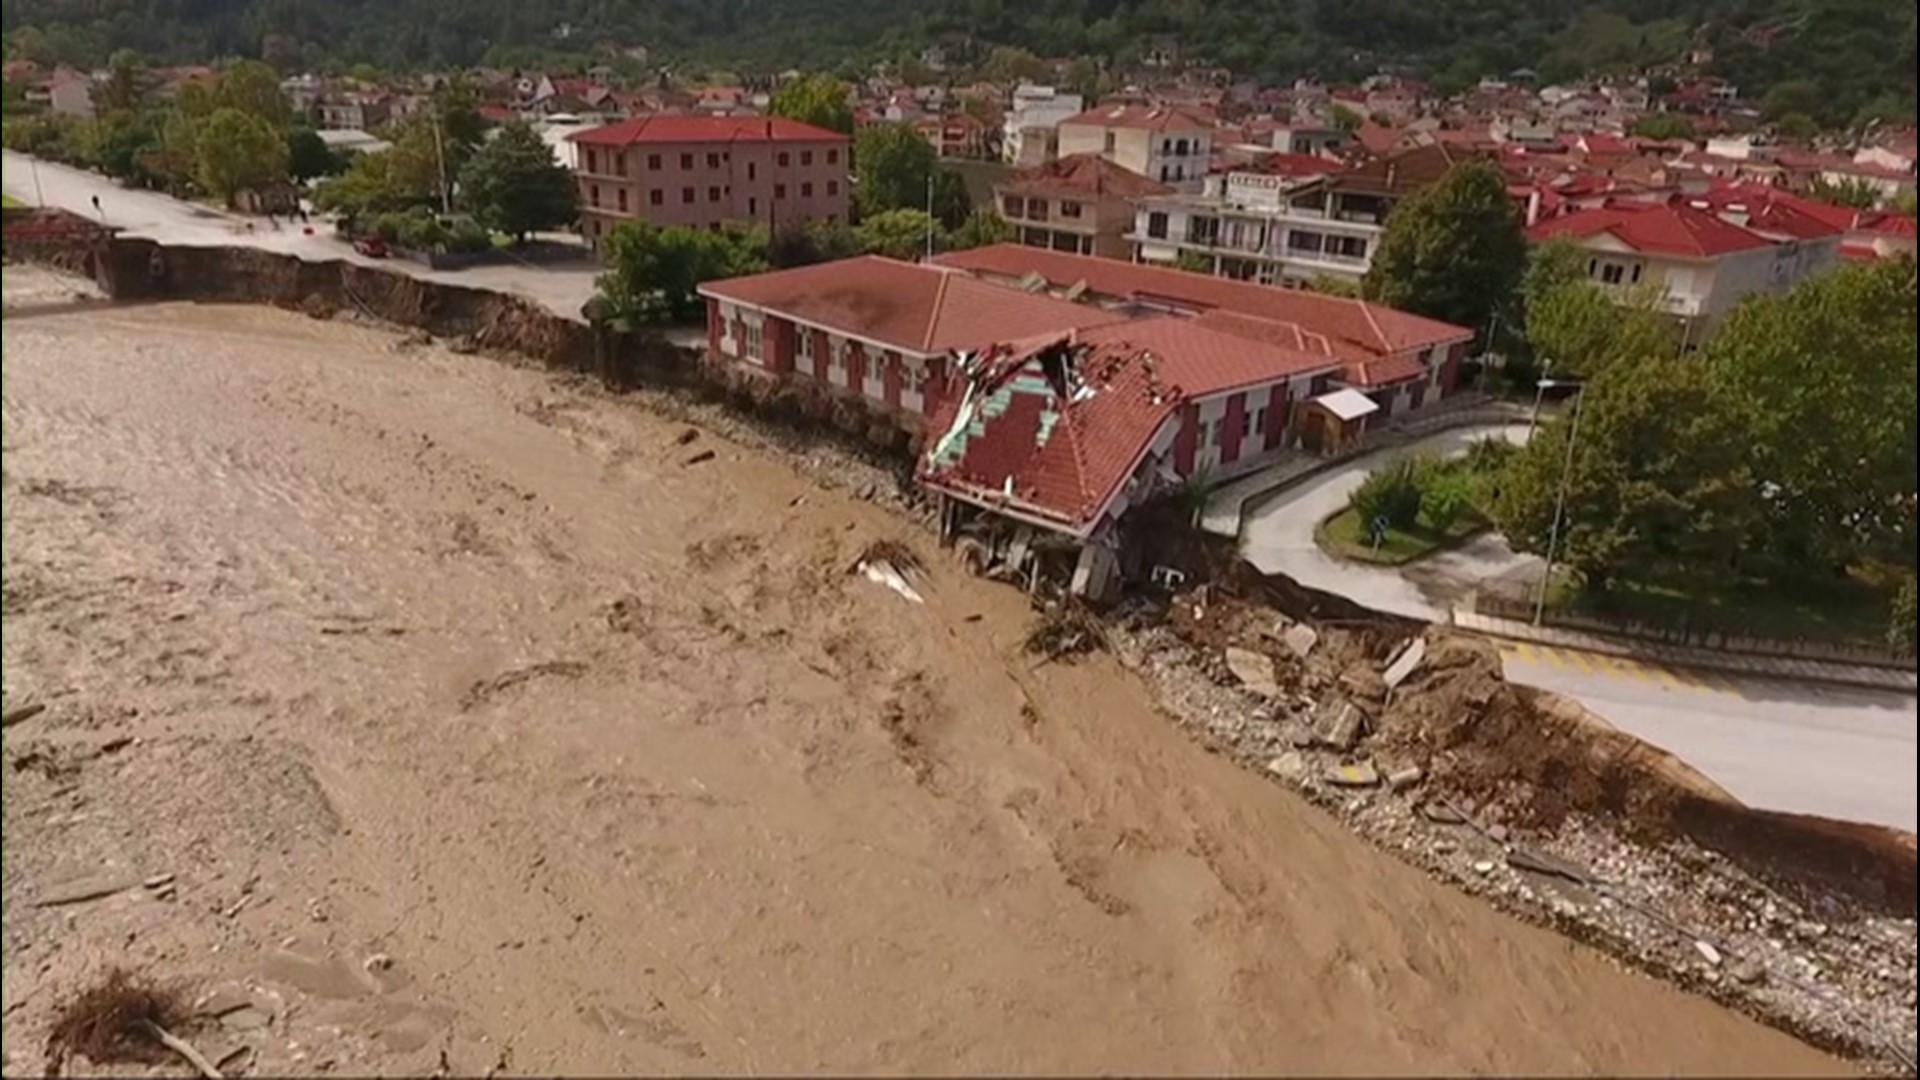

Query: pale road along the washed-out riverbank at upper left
[[0, 150, 597, 319]]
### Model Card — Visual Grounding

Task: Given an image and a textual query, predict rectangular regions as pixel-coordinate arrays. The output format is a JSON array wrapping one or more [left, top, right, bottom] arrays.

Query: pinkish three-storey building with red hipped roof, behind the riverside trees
[[570, 115, 849, 246]]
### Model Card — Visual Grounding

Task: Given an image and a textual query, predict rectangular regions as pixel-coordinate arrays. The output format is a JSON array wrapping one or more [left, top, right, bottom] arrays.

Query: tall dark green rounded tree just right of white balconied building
[[1361, 161, 1526, 331]]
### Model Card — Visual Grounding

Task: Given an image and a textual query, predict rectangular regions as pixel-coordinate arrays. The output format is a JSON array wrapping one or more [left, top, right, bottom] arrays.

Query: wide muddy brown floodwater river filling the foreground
[[4, 267, 1841, 1074]]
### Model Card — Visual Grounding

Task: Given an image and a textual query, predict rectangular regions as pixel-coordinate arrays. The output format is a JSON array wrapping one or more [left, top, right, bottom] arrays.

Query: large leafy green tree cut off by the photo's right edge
[[1707, 258, 1920, 571]]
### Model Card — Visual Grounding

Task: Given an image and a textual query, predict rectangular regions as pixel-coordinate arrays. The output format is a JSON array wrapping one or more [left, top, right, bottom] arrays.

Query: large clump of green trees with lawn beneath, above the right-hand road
[[1492, 259, 1920, 640]]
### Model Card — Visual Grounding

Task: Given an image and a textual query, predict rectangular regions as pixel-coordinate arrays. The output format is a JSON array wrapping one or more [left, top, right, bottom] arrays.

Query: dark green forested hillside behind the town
[[0, 0, 1914, 117]]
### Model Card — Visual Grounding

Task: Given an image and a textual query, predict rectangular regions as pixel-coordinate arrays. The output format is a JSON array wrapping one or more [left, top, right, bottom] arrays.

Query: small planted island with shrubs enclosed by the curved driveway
[[1313, 436, 1515, 567]]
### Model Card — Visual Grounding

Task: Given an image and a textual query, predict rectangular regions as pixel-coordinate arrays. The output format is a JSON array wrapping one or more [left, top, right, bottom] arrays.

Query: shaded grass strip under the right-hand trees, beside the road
[[1555, 567, 1899, 646]]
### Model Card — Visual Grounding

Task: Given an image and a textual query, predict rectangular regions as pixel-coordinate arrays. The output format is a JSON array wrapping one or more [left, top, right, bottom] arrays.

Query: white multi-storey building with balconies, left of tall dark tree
[[1129, 144, 1465, 286]]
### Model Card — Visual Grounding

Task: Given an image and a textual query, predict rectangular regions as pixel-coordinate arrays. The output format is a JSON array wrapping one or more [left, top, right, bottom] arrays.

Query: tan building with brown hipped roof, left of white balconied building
[[993, 154, 1173, 259]]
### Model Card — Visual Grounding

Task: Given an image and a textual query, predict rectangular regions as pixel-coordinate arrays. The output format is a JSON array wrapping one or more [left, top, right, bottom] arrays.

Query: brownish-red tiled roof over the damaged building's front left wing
[[701, 256, 1121, 354]]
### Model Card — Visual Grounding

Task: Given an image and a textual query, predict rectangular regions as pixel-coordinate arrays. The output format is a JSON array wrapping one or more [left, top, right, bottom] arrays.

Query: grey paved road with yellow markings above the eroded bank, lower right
[[1501, 642, 1920, 832]]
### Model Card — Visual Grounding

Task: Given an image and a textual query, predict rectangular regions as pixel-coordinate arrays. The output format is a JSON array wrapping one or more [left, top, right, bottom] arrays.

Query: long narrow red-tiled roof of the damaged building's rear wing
[[937, 244, 1473, 356]]
